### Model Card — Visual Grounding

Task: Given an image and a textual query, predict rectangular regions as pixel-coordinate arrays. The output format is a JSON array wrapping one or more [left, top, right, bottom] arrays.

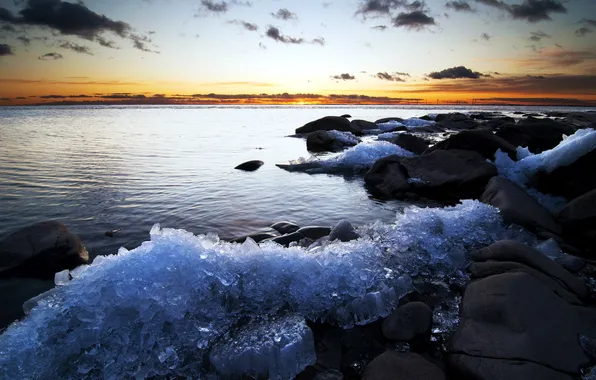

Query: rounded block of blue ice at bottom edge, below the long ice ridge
[[209, 315, 317, 380]]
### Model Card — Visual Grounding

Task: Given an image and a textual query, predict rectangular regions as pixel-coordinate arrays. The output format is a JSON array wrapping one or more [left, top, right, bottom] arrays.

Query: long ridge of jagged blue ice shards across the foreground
[[0, 200, 519, 379]]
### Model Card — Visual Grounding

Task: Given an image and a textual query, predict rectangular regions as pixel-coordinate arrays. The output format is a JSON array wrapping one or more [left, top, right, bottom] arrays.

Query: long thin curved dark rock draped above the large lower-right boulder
[[470, 240, 588, 298]]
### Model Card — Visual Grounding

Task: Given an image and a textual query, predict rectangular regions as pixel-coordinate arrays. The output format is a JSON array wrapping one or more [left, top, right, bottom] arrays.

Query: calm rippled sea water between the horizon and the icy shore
[[0, 106, 592, 256]]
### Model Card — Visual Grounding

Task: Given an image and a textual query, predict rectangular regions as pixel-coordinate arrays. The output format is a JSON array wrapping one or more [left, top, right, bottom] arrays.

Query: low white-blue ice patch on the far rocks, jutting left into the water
[[278, 141, 414, 173]]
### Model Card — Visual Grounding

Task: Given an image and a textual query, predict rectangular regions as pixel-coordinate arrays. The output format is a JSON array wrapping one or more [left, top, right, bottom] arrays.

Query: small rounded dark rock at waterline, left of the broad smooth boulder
[[364, 155, 410, 196]]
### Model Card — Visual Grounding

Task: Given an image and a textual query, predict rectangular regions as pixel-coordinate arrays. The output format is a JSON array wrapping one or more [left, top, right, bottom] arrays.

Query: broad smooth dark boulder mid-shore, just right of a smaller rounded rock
[[401, 150, 497, 199]]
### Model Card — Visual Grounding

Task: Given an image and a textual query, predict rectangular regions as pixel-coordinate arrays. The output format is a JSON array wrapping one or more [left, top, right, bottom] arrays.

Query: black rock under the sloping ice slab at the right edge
[[531, 147, 596, 199]]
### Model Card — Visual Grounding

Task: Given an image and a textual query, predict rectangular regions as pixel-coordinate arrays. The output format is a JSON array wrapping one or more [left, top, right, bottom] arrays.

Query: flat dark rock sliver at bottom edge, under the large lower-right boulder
[[449, 354, 574, 380]]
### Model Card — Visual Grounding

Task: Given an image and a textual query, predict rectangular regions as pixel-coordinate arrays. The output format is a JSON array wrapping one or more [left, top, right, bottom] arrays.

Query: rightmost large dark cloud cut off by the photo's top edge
[[476, 0, 567, 22]]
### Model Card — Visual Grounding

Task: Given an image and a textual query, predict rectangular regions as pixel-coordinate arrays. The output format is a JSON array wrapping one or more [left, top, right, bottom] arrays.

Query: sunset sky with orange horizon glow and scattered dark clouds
[[0, 0, 596, 105]]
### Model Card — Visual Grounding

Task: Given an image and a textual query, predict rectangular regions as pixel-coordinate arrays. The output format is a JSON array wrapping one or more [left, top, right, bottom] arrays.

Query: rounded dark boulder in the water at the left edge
[[0, 221, 89, 280]]
